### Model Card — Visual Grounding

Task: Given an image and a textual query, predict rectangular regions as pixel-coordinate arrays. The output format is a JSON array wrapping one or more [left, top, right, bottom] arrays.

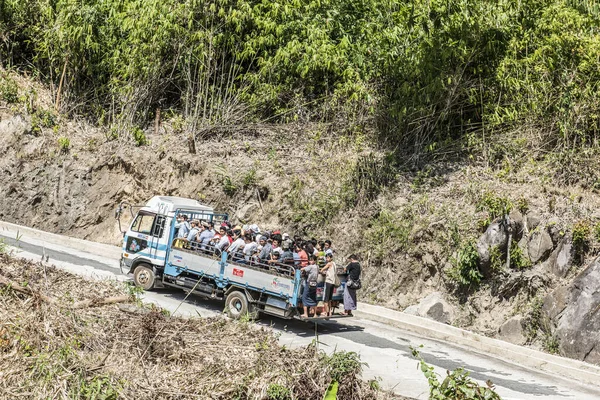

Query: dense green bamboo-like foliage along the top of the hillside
[[0, 0, 600, 151]]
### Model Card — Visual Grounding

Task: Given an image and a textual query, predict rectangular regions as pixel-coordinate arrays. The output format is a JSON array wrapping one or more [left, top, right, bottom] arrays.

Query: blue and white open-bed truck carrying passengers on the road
[[117, 196, 346, 319]]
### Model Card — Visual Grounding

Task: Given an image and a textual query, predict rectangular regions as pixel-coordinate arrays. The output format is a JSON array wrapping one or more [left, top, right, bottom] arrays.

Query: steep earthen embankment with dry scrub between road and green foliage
[[0, 70, 600, 362]]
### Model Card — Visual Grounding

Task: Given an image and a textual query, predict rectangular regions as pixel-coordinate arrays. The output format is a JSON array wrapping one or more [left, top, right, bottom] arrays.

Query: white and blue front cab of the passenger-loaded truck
[[121, 196, 227, 290]]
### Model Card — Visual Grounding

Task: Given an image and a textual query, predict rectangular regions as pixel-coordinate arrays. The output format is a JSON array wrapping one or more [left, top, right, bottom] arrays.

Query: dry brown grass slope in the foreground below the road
[[0, 255, 408, 399]]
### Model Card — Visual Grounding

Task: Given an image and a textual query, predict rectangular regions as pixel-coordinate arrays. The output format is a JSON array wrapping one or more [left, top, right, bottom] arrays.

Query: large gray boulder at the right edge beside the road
[[543, 255, 600, 364]]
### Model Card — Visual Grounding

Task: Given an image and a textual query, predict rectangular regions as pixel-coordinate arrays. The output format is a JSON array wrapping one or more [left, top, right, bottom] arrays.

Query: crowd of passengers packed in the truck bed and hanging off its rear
[[175, 214, 361, 318]]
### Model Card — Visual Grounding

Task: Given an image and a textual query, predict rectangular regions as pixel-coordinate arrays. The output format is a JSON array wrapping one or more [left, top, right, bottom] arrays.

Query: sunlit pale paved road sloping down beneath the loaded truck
[[0, 230, 600, 400]]
